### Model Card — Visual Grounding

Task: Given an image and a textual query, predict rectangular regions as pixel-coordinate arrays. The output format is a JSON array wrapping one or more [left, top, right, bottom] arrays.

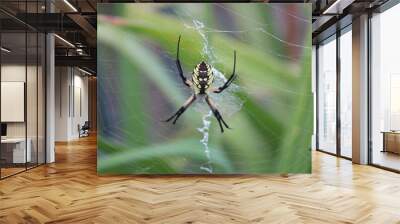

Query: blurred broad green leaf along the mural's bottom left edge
[[97, 139, 233, 174]]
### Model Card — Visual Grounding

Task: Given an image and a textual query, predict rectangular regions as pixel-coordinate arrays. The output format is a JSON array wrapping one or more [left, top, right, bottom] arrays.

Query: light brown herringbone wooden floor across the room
[[0, 138, 400, 224]]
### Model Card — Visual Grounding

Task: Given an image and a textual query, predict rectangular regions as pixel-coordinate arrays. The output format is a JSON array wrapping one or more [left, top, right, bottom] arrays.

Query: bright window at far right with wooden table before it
[[370, 2, 400, 170]]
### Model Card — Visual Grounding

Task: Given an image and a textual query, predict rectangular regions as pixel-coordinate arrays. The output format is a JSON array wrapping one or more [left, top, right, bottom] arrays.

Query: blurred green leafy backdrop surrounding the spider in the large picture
[[97, 3, 313, 174]]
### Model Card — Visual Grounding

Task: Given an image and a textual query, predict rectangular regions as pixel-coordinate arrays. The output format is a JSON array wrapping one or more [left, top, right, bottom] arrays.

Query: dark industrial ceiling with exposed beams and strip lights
[[0, 0, 394, 72]]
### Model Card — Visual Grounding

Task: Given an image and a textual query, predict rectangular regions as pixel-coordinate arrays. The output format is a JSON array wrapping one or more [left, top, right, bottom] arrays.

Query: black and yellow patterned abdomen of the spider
[[192, 61, 214, 94]]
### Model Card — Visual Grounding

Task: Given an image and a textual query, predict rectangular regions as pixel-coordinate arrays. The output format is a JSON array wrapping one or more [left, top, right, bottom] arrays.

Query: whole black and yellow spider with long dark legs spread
[[165, 35, 237, 133]]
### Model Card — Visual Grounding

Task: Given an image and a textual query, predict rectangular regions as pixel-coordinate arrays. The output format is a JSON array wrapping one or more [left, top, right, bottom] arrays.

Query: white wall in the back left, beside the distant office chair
[[55, 67, 88, 141]]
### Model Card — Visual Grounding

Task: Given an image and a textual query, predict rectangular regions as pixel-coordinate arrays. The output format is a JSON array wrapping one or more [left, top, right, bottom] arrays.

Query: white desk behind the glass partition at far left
[[1, 138, 32, 163]]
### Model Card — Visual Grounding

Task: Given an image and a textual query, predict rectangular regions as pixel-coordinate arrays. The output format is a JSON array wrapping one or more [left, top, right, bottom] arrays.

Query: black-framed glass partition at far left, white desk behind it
[[0, 1, 46, 178]]
